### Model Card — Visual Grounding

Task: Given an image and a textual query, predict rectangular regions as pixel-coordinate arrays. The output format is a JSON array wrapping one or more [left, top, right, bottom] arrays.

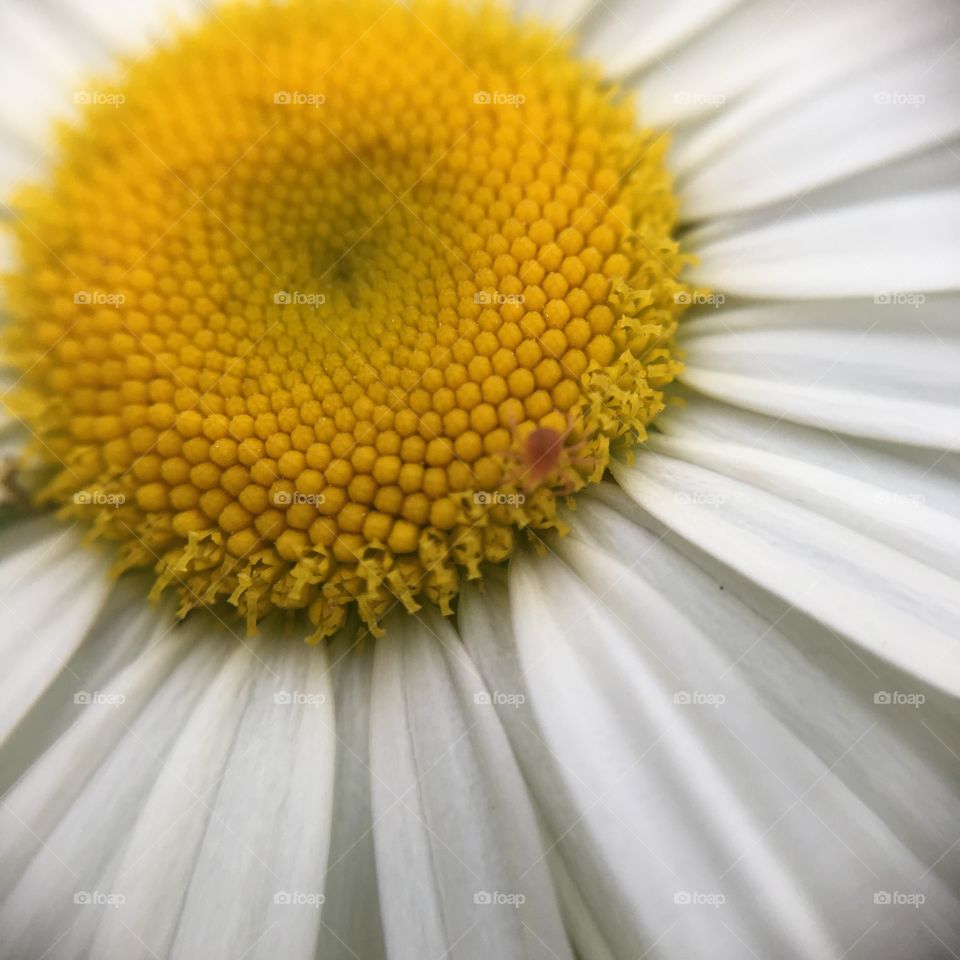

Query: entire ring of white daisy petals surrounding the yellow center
[[0, 0, 960, 960]]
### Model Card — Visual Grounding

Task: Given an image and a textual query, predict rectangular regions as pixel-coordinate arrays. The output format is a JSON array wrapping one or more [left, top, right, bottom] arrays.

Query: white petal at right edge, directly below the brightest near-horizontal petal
[[682, 290, 960, 450]]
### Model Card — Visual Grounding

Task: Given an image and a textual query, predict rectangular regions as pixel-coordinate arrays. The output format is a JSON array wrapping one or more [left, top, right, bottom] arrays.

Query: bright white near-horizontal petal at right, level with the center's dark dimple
[[689, 190, 960, 299]]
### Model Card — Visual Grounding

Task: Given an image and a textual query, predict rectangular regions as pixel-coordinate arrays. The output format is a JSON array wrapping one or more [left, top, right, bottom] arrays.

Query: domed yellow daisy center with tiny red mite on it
[[5, 0, 689, 638]]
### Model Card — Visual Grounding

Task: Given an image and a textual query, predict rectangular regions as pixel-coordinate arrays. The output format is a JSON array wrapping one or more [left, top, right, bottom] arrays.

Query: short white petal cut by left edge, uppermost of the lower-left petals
[[0, 520, 111, 743]]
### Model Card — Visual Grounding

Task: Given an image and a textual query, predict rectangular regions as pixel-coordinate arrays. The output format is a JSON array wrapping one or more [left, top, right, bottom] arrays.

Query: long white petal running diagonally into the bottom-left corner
[[0, 618, 230, 956]]
